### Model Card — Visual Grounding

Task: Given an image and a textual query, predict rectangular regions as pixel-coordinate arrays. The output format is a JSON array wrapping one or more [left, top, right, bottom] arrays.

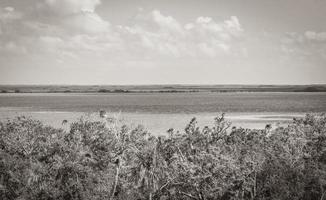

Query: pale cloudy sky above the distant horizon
[[0, 0, 326, 85]]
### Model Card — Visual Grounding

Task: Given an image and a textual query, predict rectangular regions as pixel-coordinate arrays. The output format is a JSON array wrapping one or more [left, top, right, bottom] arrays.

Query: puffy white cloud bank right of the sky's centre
[[121, 10, 243, 58]]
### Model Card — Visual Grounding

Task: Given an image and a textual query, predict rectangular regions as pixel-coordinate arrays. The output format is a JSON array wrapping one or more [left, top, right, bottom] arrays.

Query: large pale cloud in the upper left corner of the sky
[[0, 0, 114, 57]]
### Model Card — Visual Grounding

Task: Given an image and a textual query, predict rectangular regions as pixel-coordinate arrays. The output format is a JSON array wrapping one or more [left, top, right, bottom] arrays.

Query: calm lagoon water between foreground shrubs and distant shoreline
[[0, 92, 326, 134]]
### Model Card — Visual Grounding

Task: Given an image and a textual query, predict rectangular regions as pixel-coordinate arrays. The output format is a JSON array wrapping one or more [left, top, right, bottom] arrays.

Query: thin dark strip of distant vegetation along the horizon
[[0, 85, 326, 93]]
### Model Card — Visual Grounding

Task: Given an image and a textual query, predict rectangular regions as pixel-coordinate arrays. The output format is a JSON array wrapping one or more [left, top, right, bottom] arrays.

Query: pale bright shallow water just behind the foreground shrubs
[[0, 110, 304, 135]]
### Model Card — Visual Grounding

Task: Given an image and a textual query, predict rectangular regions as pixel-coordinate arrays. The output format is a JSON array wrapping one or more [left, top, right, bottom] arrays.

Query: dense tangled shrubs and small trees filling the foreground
[[0, 115, 326, 200]]
